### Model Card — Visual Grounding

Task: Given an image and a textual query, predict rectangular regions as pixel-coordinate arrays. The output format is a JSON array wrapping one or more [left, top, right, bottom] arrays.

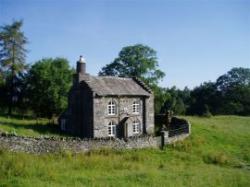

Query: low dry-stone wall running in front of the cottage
[[0, 130, 189, 154]]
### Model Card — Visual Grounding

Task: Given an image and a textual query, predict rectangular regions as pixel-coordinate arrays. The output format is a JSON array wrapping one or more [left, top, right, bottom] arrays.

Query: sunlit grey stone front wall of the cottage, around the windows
[[93, 96, 145, 137]]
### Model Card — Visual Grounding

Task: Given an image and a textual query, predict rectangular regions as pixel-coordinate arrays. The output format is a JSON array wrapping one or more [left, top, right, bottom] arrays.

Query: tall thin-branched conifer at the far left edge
[[0, 21, 27, 115]]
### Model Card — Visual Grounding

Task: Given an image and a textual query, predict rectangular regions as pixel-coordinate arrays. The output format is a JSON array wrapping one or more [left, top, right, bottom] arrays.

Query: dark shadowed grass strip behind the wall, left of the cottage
[[0, 121, 69, 136]]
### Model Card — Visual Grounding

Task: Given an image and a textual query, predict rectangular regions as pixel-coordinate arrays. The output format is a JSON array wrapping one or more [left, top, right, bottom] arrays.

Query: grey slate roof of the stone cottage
[[84, 76, 151, 96]]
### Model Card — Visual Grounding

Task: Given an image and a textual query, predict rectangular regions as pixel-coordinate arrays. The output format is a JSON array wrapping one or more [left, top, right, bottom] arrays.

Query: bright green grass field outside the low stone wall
[[0, 116, 250, 187]]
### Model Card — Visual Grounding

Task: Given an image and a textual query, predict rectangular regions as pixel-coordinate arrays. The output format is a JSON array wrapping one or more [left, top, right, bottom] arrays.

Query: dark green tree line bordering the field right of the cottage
[[155, 68, 250, 117]]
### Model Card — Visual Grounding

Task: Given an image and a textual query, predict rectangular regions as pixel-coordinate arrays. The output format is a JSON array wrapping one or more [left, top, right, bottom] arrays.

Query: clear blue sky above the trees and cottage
[[0, 0, 250, 89]]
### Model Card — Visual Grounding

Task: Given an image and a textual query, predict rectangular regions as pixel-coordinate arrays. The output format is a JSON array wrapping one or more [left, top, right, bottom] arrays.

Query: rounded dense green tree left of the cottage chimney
[[27, 58, 73, 119]]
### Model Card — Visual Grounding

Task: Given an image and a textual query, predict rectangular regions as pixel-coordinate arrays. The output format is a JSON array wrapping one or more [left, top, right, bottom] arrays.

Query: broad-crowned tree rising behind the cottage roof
[[99, 44, 165, 86]]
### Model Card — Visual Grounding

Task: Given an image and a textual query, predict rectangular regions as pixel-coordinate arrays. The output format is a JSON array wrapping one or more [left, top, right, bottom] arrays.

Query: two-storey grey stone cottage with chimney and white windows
[[59, 56, 154, 138]]
